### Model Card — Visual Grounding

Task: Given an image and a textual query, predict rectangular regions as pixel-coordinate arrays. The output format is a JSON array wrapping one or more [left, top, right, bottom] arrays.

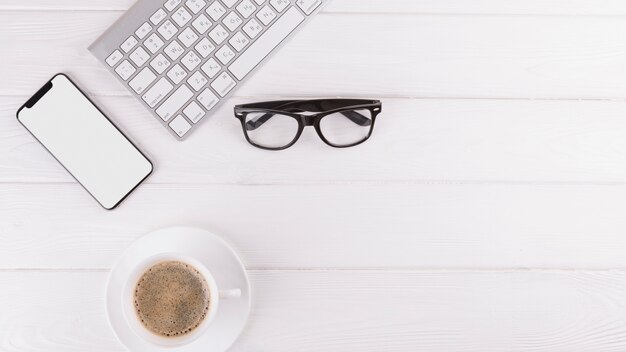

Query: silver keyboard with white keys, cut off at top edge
[[89, 0, 328, 141]]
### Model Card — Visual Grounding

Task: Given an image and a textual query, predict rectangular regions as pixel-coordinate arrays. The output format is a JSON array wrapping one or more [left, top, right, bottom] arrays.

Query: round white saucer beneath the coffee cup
[[106, 227, 250, 352]]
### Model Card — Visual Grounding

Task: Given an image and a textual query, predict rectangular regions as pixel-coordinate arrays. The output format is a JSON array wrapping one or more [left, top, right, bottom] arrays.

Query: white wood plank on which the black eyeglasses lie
[[6, 97, 626, 184]]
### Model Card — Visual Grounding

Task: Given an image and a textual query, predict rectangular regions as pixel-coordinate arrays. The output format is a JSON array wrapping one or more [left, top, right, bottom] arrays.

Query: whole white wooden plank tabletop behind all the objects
[[0, 0, 626, 352]]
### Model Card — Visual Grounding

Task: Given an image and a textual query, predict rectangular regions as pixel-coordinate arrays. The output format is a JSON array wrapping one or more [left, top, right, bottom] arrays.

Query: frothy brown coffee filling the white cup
[[134, 261, 211, 337]]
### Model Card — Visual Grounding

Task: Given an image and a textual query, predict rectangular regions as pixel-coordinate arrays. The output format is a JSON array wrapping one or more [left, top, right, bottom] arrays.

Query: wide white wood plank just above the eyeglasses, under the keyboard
[[0, 11, 626, 99]]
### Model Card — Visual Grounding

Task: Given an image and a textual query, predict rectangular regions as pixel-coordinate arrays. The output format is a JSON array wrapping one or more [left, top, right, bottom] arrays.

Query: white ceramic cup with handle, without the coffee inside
[[122, 253, 241, 347]]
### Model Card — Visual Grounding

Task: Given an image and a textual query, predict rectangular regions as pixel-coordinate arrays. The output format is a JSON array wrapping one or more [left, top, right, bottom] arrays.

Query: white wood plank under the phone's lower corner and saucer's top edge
[[0, 184, 626, 269]]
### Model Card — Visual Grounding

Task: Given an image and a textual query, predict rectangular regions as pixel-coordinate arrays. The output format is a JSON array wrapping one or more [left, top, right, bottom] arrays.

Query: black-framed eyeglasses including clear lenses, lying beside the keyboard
[[235, 99, 382, 150]]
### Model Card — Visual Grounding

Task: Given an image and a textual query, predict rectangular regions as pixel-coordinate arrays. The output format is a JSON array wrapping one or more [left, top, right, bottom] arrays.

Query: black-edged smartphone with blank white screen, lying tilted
[[17, 74, 153, 210]]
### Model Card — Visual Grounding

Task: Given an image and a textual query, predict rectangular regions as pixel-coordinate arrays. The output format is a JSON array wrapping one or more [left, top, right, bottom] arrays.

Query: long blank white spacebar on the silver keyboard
[[228, 7, 304, 81]]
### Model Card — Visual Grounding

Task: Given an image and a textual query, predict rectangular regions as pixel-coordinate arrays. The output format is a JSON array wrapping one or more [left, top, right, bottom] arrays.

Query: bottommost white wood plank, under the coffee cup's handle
[[0, 271, 626, 352]]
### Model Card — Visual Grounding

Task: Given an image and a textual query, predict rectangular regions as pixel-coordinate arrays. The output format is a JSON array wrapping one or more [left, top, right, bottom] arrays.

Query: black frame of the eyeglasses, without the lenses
[[234, 99, 382, 151]]
